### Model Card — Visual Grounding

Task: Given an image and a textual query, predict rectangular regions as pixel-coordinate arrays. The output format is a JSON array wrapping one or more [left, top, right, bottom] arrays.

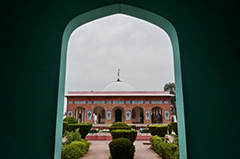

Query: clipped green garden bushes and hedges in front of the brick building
[[61, 117, 179, 159]]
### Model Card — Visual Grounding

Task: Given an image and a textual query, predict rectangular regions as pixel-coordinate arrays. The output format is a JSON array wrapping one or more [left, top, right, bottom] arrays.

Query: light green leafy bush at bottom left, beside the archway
[[61, 140, 90, 159]]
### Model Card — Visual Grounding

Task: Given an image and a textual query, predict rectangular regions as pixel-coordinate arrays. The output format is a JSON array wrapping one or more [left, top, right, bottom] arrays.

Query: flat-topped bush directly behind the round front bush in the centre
[[111, 129, 137, 142]]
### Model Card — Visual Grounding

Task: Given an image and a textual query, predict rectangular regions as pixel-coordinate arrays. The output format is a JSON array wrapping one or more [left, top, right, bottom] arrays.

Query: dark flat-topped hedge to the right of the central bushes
[[148, 125, 168, 137]]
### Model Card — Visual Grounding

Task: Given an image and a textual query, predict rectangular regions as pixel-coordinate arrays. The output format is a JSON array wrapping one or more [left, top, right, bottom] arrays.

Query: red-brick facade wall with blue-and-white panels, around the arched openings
[[67, 96, 171, 124]]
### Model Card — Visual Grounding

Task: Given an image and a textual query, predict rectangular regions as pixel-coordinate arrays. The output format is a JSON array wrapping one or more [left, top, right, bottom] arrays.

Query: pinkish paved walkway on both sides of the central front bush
[[82, 140, 161, 159]]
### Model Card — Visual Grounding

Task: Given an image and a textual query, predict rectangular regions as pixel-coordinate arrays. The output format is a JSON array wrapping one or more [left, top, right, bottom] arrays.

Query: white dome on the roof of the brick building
[[103, 80, 136, 91]]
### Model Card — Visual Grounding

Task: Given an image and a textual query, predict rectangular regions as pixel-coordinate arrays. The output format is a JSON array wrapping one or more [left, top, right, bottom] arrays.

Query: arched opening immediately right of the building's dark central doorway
[[132, 107, 144, 124]]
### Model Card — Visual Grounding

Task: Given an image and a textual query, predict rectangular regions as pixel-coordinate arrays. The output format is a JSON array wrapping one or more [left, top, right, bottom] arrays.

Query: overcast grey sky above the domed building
[[65, 14, 174, 93]]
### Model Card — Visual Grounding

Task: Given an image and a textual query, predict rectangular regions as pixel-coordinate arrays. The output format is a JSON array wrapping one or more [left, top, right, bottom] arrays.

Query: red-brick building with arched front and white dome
[[65, 77, 173, 124]]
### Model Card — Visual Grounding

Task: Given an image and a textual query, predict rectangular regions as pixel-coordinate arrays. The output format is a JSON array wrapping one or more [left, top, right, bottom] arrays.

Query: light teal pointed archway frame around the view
[[54, 4, 187, 159]]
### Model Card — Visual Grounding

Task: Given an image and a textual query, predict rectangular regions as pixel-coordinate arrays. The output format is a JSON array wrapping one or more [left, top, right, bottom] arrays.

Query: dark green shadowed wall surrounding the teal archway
[[0, 0, 240, 159]]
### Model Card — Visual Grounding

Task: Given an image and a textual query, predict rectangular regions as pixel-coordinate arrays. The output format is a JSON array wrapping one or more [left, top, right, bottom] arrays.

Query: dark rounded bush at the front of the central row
[[109, 138, 135, 159]]
